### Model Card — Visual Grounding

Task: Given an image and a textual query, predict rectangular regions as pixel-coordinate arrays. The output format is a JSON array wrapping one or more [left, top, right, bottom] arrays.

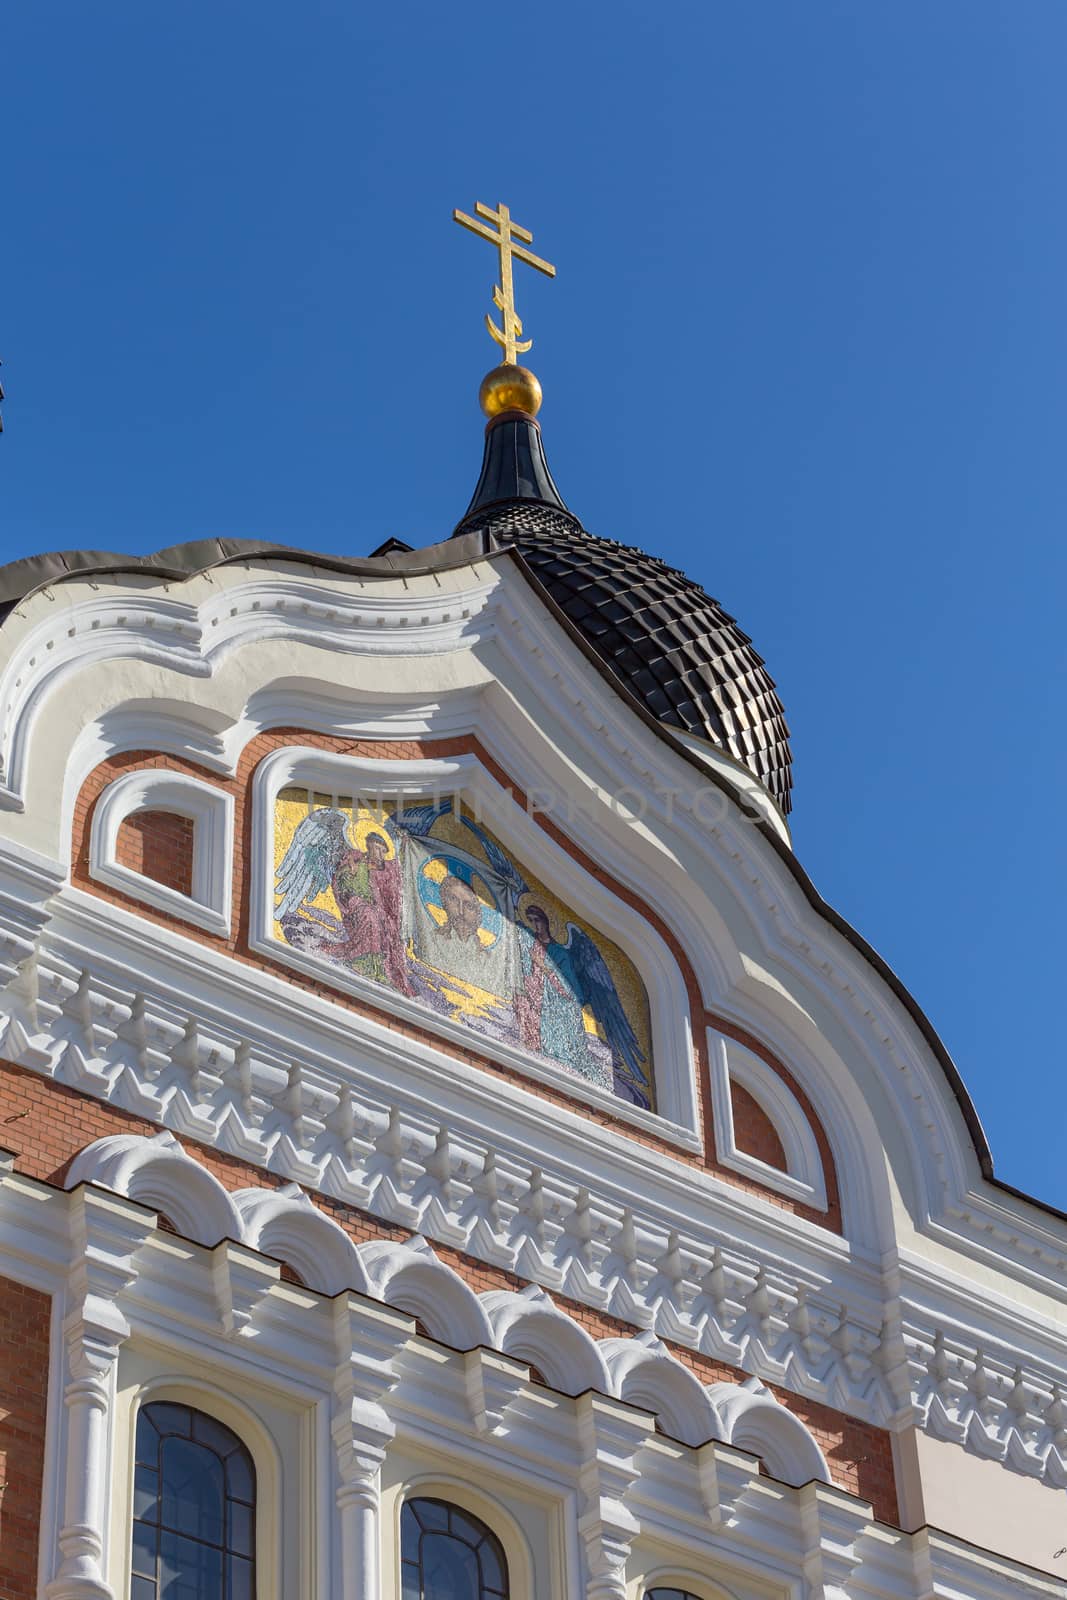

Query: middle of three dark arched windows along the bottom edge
[[400, 1499, 507, 1600]]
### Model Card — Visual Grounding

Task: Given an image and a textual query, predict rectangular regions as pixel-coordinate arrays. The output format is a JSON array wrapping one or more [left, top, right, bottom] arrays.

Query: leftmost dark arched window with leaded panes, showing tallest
[[130, 1402, 256, 1600]]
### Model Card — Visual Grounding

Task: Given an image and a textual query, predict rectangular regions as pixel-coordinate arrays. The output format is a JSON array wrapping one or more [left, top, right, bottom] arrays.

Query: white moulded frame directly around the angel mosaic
[[248, 746, 701, 1149]]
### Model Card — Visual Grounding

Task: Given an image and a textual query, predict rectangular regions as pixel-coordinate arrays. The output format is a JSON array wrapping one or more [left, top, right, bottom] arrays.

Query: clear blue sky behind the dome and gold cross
[[0, 0, 1067, 1206]]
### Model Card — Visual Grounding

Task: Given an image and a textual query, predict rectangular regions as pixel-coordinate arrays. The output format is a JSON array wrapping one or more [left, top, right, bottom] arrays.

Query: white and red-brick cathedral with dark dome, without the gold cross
[[0, 228, 1067, 1600]]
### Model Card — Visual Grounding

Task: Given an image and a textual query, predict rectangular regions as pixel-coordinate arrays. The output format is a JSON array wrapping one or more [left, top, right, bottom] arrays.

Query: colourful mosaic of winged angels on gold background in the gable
[[274, 786, 654, 1110]]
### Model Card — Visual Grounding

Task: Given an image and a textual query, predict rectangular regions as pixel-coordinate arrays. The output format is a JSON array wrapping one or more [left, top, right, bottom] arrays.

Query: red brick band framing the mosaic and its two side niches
[[70, 728, 843, 1234]]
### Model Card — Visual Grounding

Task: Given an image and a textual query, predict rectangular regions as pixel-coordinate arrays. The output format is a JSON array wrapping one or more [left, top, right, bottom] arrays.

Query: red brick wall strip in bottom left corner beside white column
[[0, 1278, 51, 1600]]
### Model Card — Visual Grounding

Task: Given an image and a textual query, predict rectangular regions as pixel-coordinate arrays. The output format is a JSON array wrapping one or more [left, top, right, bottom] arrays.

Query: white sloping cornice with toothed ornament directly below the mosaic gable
[[0, 891, 902, 1424]]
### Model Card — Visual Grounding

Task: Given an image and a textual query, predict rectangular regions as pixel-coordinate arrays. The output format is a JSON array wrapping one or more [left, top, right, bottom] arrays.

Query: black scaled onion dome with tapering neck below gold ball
[[456, 413, 792, 811]]
